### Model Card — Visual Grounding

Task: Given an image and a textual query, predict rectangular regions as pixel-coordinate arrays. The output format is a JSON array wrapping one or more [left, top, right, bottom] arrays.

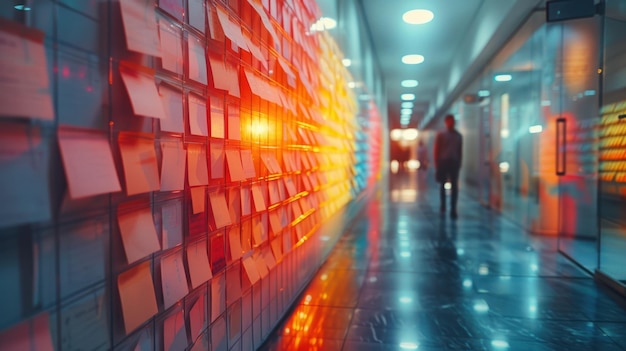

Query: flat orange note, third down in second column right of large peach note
[[161, 140, 187, 191]]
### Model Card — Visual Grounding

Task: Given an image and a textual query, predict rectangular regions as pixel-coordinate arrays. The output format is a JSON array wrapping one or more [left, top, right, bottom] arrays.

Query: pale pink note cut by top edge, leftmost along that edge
[[119, 0, 161, 57]]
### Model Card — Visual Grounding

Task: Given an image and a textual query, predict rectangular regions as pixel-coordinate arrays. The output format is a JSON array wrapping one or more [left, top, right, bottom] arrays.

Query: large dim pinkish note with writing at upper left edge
[[0, 19, 54, 121]]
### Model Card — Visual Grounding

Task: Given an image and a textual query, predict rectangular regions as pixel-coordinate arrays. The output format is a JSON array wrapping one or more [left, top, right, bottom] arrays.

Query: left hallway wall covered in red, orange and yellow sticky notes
[[0, 0, 386, 351]]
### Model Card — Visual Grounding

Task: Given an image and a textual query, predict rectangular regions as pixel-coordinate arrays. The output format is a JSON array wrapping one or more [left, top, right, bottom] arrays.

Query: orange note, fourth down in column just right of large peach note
[[117, 205, 161, 263]]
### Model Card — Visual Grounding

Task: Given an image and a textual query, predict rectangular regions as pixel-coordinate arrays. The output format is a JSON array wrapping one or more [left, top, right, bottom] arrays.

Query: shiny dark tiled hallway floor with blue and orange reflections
[[262, 177, 626, 351]]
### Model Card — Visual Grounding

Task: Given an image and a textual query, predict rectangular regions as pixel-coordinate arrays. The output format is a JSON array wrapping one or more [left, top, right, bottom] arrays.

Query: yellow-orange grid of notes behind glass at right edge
[[599, 102, 626, 190]]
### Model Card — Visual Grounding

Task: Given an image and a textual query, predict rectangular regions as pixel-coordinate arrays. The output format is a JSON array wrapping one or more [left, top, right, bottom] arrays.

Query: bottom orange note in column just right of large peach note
[[117, 261, 158, 334]]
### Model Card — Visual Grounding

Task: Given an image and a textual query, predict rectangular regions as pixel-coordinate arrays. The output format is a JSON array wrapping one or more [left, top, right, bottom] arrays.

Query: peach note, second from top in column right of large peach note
[[120, 65, 165, 119]]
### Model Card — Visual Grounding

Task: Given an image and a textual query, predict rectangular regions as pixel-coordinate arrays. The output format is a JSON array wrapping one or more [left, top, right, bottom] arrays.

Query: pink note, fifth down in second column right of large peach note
[[161, 250, 189, 309]]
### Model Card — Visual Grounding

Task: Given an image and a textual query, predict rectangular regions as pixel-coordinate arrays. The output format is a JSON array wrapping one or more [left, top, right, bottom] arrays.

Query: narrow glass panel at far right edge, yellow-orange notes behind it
[[599, 0, 626, 287]]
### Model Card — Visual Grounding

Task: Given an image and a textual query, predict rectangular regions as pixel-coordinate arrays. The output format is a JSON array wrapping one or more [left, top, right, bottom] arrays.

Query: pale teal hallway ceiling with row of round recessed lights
[[326, 0, 543, 128]]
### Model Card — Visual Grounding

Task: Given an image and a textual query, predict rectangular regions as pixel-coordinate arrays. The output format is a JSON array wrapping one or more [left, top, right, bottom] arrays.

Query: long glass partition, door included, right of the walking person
[[455, 11, 600, 272]]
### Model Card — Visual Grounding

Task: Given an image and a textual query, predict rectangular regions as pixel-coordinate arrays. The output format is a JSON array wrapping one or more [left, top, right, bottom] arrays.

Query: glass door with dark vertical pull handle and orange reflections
[[551, 16, 601, 272]]
